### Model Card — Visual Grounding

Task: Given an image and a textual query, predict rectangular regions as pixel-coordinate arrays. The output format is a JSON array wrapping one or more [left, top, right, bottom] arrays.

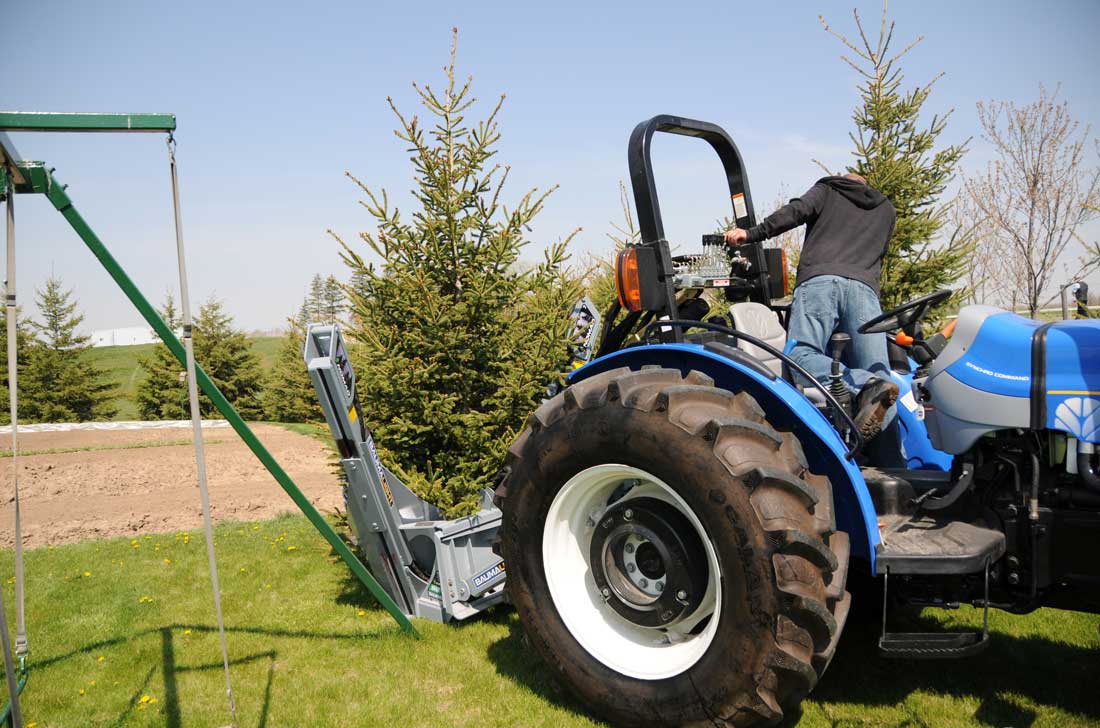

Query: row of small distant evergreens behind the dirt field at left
[[0, 275, 348, 424]]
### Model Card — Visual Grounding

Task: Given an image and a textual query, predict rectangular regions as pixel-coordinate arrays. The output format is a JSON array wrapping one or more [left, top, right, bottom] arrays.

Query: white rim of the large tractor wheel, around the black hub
[[542, 464, 722, 680]]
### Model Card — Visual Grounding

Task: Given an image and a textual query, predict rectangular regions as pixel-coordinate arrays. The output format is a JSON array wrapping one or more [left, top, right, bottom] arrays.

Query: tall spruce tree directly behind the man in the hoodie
[[821, 3, 974, 308]]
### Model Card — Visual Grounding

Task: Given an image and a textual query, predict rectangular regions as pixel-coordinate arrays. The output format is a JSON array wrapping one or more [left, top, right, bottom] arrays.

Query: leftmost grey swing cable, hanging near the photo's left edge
[[0, 175, 26, 728]]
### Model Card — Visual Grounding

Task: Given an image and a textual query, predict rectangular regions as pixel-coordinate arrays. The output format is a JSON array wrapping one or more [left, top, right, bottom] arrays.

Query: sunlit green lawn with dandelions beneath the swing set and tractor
[[0, 516, 1100, 728]]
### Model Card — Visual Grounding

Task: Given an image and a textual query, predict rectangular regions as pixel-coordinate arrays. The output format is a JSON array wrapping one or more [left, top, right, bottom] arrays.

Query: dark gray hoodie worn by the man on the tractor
[[748, 177, 897, 295]]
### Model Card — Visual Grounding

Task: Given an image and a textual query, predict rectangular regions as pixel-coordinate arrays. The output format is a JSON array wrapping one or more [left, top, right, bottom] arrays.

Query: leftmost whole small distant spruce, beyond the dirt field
[[21, 276, 117, 422]]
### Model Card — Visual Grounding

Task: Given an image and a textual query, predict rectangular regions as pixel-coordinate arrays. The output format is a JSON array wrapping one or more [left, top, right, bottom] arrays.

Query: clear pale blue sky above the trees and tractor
[[0, 0, 1100, 330]]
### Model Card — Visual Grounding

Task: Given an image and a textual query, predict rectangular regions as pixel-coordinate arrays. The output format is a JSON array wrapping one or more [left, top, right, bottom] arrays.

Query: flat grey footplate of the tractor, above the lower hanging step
[[876, 515, 1004, 574]]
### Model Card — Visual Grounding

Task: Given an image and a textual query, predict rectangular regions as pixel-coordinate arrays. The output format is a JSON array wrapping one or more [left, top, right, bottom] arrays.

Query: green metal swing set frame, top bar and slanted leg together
[[0, 117, 419, 651]]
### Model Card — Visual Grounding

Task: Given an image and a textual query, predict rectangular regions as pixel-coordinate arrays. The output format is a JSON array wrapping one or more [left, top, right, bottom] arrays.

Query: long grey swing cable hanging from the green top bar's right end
[[168, 133, 238, 728]]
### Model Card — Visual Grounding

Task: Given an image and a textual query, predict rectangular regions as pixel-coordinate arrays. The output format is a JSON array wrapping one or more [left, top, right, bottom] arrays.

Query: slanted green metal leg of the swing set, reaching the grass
[[17, 162, 419, 637]]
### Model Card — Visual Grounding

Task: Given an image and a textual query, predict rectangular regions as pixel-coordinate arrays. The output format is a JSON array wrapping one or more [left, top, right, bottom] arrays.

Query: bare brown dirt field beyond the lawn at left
[[0, 424, 342, 548]]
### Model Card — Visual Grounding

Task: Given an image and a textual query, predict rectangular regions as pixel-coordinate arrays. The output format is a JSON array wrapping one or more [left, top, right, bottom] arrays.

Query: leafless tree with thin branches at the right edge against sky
[[965, 86, 1100, 318]]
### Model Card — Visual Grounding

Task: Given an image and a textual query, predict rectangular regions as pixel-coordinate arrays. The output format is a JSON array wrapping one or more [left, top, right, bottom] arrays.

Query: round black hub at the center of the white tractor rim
[[589, 497, 707, 628]]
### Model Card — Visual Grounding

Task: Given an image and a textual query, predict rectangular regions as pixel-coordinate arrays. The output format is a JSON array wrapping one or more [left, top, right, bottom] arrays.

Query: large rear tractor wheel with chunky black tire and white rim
[[496, 367, 850, 726]]
